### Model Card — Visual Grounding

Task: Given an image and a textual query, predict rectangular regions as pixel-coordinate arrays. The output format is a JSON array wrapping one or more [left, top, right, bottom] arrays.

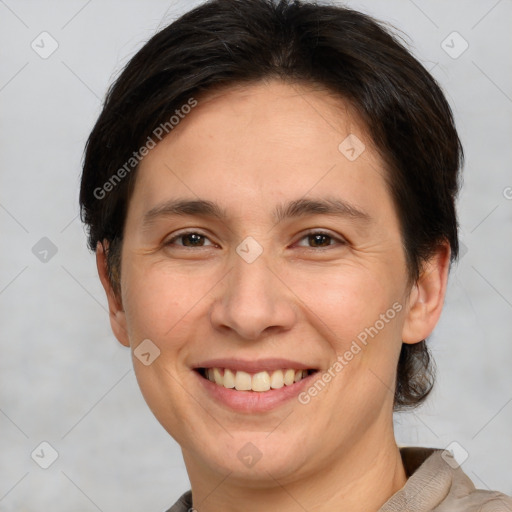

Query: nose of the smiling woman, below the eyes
[[210, 247, 296, 340]]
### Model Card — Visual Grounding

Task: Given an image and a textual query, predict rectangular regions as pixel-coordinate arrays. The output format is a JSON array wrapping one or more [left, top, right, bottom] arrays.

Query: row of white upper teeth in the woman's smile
[[202, 368, 308, 392]]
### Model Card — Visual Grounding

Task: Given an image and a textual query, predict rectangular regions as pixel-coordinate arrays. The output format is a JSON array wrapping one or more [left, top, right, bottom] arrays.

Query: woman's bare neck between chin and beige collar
[[185, 433, 407, 512]]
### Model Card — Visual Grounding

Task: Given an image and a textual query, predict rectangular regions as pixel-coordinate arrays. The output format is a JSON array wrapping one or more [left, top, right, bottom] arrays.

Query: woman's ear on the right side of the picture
[[402, 241, 451, 344]]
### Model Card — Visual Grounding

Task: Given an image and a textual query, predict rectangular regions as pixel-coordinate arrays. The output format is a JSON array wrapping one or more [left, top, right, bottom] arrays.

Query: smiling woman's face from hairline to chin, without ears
[[104, 81, 428, 485]]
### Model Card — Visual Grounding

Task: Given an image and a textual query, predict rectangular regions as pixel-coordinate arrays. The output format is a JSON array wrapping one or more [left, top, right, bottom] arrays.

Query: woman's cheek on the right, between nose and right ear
[[287, 264, 404, 390]]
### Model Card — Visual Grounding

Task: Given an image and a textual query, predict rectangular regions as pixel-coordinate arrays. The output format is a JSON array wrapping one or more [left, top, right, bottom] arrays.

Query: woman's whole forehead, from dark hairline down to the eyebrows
[[128, 80, 389, 224]]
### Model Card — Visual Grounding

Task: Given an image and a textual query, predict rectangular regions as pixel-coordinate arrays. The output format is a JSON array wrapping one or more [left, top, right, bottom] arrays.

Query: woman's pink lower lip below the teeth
[[194, 371, 316, 413]]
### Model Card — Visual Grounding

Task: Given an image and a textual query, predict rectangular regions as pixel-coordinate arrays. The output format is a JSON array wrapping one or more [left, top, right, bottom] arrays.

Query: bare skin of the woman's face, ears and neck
[[97, 80, 450, 512]]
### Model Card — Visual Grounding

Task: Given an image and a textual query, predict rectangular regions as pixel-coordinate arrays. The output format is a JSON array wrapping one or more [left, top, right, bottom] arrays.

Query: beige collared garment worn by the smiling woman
[[167, 447, 512, 512]]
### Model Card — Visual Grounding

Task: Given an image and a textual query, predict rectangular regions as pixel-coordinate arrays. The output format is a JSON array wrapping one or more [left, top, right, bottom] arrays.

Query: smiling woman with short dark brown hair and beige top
[[80, 0, 512, 512]]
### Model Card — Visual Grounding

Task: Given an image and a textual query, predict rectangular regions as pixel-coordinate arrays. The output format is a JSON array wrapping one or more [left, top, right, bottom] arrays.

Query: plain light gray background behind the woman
[[0, 0, 512, 512]]
